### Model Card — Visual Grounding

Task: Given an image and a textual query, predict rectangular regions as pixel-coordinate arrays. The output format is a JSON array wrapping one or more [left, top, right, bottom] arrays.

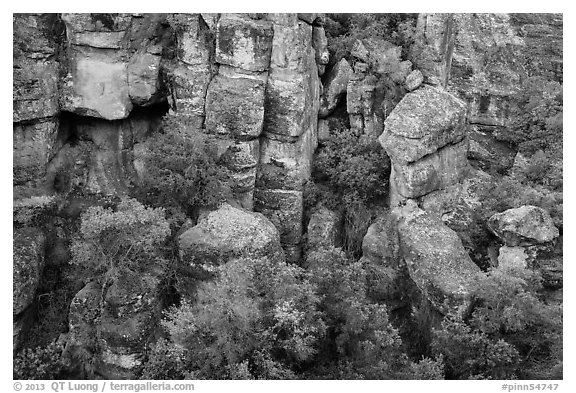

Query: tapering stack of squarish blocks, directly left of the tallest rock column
[[205, 14, 274, 210]]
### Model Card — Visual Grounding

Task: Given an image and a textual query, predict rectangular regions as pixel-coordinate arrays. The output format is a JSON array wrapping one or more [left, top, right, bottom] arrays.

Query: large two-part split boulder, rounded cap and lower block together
[[379, 86, 468, 206]]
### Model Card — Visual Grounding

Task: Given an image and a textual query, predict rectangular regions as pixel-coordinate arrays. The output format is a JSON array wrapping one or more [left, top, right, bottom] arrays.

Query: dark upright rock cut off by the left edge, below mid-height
[[12, 227, 46, 315]]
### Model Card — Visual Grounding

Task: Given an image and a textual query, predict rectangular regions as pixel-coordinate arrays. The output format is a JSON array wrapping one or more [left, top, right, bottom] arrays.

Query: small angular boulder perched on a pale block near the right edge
[[488, 206, 559, 246]]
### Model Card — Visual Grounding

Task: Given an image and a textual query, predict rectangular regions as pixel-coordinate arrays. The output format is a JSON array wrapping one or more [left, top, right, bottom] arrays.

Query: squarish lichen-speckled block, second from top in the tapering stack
[[206, 74, 266, 139]]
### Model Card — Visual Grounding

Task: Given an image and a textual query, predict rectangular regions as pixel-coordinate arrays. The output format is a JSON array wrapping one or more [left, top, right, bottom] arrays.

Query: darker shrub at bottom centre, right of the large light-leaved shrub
[[306, 248, 408, 379]]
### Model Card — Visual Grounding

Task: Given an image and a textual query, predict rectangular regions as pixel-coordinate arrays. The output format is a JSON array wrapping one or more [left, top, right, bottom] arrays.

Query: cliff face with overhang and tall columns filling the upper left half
[[13, 14, 327, 259]]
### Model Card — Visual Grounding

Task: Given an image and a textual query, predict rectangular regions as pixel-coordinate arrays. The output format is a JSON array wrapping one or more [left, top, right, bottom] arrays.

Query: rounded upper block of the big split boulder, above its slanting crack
[[379, 86, 467, 164]]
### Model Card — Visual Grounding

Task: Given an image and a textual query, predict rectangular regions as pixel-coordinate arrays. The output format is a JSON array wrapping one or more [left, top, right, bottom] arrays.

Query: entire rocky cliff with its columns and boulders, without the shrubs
[[13, 13, 562, 379]]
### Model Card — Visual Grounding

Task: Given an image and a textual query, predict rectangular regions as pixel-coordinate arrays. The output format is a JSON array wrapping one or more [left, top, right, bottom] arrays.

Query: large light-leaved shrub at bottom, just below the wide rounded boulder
[[164, 259, 324, 379]]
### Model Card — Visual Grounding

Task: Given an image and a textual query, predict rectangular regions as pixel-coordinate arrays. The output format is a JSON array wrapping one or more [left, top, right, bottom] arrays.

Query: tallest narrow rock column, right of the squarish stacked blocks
[[255, 14, 320, 261]]
